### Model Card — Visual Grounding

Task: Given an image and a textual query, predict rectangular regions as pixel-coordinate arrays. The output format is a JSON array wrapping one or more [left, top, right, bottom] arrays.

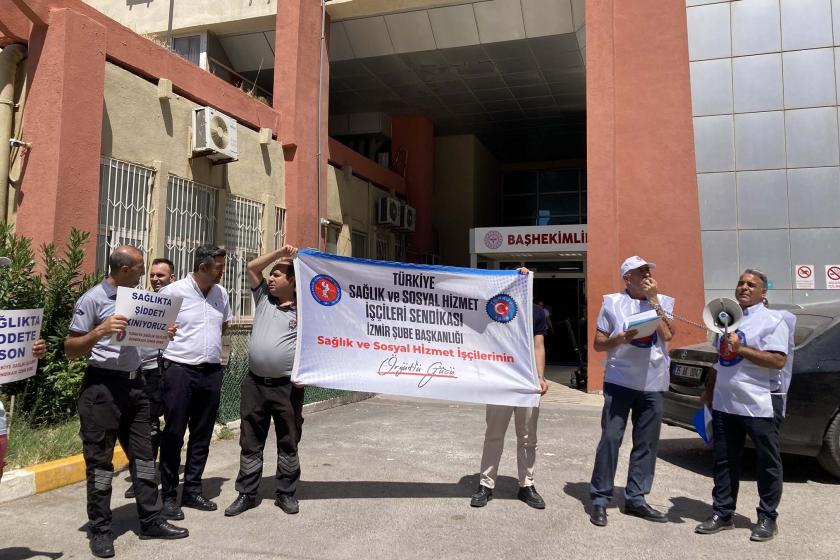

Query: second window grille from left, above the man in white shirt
[[165, 175, 216, 278]]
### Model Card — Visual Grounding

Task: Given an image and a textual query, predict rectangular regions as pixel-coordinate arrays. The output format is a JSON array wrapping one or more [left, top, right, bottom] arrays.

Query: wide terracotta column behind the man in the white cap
[[586, 0, 708, 391]]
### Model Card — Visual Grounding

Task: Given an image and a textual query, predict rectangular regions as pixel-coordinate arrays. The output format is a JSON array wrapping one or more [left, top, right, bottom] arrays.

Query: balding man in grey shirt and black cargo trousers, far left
[[64, 245, 189, 558]]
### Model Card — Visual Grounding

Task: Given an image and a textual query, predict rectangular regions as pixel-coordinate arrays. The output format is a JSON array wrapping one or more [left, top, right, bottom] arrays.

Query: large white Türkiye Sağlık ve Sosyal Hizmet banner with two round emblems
[[292, 250, 539, 406]]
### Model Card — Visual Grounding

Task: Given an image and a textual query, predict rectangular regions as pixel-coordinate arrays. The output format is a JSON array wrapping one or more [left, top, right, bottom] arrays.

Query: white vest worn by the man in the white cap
[[597, 291, 675, 391]]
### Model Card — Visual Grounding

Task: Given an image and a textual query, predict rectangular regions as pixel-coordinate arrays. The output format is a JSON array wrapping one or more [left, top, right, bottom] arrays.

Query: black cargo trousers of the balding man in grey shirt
[[78, 366, 160, 532]]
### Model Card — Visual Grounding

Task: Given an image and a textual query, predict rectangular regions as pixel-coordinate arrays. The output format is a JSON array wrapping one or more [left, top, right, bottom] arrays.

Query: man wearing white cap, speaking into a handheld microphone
[[589, 256, 674, 527]]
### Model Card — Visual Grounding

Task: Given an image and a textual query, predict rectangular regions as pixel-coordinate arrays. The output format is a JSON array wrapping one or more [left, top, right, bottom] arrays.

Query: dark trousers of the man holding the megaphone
[[712, 395, 784, 519]]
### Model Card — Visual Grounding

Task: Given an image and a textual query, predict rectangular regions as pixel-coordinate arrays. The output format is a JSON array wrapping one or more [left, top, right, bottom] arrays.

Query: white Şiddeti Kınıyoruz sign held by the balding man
[[110, 286, 182, 348]]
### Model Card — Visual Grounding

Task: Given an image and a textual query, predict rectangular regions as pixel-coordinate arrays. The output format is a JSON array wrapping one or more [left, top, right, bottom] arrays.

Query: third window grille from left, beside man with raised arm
[[222, 196, 262, 319]]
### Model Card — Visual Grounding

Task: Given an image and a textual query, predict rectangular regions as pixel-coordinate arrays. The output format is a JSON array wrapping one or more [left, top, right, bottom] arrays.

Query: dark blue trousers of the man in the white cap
[[589, 383, 662, 507]]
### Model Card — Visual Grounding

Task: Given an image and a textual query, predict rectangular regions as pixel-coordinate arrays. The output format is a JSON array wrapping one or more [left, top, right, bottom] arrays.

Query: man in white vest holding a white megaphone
[[695, 269, 796, 541]]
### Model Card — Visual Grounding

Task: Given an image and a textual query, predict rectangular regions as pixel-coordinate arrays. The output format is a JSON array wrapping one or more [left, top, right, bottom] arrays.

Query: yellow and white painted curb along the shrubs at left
[[0, 393, 374, 504]]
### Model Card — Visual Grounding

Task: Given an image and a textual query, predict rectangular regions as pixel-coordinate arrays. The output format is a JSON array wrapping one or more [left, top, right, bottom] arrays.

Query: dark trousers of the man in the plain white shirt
[[160, 360, 223, 499]]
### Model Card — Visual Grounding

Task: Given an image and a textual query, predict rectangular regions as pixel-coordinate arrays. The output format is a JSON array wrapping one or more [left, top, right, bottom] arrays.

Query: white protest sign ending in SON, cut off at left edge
[[0, 309, 44, 384]]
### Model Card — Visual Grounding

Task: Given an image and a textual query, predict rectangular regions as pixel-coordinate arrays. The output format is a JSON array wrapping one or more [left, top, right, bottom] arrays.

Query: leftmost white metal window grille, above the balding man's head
[[96, 157, 155, 273]]
